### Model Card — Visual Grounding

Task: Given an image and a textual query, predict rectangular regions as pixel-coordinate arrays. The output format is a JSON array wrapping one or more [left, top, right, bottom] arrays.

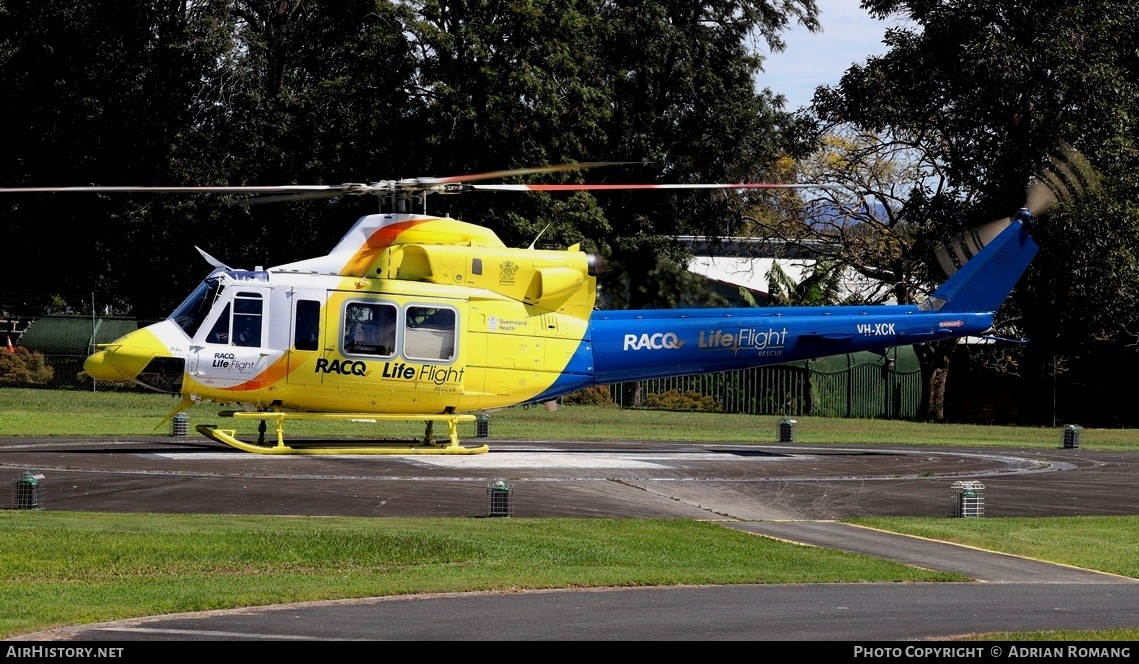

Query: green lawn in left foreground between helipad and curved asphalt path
[[0, 511, 964, 638]]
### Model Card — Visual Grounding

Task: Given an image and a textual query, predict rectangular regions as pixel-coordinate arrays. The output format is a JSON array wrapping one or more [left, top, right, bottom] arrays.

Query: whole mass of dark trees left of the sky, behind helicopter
[[0, 0, 818, 319]]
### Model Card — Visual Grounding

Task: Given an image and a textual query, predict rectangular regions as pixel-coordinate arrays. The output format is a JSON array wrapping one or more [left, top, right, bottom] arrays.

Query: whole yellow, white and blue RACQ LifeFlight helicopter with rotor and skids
[[0, 163, 1038, 454]]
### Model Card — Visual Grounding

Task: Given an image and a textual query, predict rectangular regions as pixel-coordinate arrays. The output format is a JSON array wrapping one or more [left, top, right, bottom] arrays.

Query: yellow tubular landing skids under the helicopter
[[195, 411, 490, 454]]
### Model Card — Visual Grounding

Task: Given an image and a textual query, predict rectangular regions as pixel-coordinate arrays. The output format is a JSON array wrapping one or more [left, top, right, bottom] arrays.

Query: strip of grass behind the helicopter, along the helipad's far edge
[[0, 387, 1139, 450]]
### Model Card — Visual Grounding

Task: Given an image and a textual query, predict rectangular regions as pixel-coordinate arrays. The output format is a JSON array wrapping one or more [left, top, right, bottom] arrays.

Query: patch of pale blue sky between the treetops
[[756, 0, 896, 110]]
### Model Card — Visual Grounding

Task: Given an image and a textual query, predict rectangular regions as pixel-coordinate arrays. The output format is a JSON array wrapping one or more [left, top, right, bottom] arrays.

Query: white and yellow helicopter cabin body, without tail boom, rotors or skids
[[85, 215, 596, 415]]
